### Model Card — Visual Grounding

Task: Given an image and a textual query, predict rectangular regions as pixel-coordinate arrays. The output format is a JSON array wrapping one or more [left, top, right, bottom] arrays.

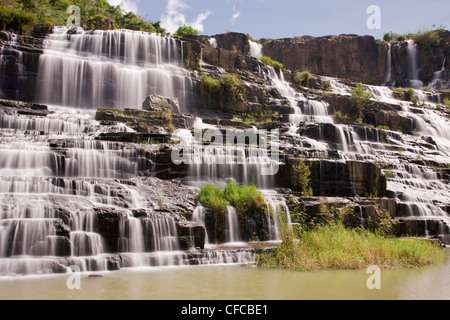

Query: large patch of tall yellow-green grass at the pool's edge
[[257, 220, 444, 271]]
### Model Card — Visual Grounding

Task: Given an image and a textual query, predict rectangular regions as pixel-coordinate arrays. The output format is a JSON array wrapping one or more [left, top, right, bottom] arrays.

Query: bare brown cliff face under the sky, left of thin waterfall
[[261, 35, 388, 84]]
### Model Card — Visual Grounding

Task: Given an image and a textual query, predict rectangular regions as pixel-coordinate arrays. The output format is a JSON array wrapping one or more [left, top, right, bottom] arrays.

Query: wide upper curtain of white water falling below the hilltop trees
[[37, 27, 195, 110]]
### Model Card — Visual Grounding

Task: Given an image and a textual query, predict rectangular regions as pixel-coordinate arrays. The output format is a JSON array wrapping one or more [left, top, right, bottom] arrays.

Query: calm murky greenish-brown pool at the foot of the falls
[[0, 250, 450, 300]]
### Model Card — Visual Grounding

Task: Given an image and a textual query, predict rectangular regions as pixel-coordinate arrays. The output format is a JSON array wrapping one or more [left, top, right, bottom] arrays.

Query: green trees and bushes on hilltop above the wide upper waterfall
[[0, 0, 166, 35]]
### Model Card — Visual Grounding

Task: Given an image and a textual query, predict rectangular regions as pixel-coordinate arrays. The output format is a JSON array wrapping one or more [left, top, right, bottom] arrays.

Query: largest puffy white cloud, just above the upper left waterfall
[[161, 0, 212, 33]]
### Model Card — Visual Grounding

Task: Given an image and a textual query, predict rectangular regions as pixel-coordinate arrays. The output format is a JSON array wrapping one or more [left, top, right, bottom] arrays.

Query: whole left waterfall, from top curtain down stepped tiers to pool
[[0, 28, 260, 276]]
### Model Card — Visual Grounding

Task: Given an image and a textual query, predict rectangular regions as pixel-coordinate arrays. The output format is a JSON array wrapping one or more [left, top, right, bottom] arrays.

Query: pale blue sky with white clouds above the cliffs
[[108, 0, 450, 39]]
